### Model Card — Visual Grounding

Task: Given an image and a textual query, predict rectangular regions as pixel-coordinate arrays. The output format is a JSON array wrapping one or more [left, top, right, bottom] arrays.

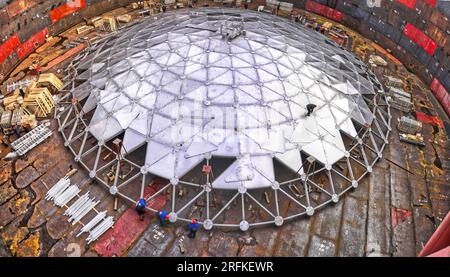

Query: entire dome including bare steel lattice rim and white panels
[[57, 8, 391, 230]]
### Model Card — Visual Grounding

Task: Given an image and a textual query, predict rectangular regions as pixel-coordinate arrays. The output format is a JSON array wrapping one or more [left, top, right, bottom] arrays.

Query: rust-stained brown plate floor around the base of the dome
[[0, 3, 450, 256]]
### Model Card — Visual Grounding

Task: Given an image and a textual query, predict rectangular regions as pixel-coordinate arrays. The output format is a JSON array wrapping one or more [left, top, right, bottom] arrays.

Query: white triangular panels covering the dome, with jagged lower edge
[[66, 8, 384, 188]]
